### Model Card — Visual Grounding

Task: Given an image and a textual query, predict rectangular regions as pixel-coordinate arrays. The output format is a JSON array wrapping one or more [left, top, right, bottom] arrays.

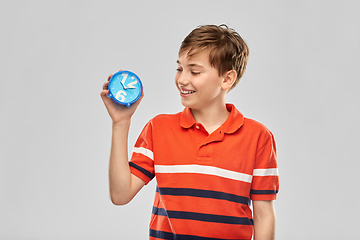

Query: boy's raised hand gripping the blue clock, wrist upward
[[100, 70, 144, 124]]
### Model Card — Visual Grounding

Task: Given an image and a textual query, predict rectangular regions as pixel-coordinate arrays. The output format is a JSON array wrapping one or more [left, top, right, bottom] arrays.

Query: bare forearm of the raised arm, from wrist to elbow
[[109, 119, 131, 205]]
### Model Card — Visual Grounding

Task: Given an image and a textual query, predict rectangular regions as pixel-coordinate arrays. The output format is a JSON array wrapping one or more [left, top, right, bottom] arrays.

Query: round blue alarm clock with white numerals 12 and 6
[[108, 71, 142, 107]]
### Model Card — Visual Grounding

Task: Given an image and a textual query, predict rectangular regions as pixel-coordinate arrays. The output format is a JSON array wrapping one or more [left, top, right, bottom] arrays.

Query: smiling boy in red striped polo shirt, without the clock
[[101, 25, 279, 240]]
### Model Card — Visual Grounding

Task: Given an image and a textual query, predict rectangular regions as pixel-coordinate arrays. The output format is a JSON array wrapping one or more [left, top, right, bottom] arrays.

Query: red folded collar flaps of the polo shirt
[[180, 104, 244, 134]]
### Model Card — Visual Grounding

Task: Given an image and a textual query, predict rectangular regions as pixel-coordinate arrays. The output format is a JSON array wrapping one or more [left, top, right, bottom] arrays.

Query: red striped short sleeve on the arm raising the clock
[[129, 121, 155, 184]]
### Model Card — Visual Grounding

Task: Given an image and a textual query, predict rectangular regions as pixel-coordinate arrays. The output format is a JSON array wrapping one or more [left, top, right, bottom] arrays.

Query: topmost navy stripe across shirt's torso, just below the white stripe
[[156, 187, 250, 205]]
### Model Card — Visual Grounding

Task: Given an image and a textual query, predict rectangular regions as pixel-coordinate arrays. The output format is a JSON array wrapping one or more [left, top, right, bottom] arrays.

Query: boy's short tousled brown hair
[[179, 24, 249, 90]]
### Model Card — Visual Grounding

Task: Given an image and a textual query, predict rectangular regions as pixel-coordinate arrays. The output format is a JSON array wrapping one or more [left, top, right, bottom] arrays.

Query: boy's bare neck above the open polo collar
[[191, 103, 230, 134]]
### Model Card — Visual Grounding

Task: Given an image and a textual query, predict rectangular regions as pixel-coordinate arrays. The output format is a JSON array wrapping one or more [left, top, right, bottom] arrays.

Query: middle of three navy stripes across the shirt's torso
[[152, 207, 253, 225]]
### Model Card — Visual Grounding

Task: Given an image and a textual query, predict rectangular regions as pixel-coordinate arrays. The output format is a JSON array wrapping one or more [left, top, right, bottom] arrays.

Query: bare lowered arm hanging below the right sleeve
[[253, 201, 276, 240]]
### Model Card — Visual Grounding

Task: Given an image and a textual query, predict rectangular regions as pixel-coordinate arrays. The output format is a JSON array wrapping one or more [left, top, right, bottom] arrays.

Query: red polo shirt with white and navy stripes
[[130, 104, 279, 240]]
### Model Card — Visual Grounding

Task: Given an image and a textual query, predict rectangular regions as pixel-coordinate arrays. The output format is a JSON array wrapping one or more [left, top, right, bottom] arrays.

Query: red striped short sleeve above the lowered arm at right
[[250, 134, 279, 201]]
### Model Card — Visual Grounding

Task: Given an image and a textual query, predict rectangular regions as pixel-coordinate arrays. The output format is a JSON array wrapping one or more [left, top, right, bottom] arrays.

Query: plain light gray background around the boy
[[0, 0, 360, 240]]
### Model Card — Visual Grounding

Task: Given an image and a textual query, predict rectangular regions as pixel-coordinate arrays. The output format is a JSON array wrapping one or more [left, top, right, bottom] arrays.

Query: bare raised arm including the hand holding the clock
[[100, 72, 145, 205]]
